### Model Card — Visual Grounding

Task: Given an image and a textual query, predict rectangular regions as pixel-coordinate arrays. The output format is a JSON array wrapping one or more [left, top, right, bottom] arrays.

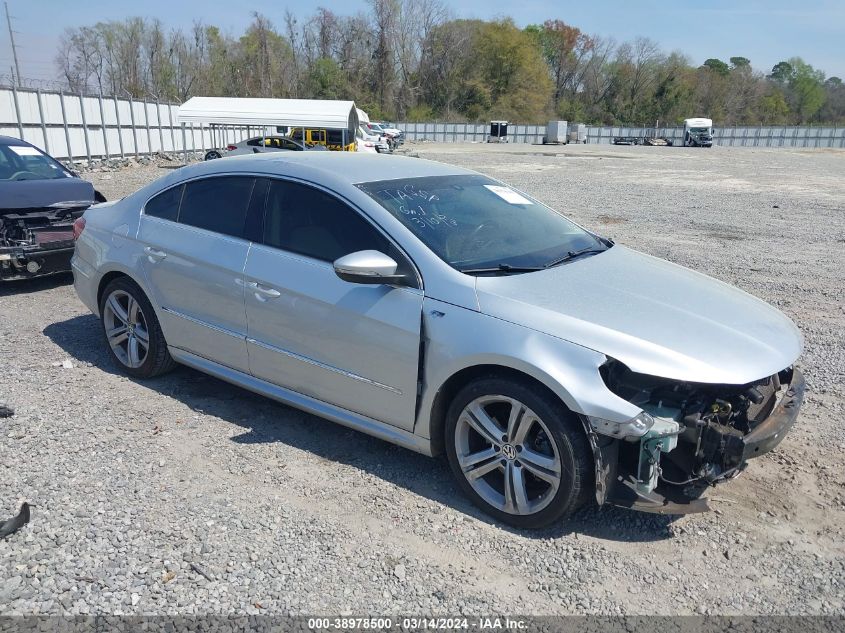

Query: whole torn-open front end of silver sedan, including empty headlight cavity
[[584, 360, 805, 514]]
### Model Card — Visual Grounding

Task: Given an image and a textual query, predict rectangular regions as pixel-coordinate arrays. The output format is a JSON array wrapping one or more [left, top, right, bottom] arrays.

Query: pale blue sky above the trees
[[0, 0, 845, 85]]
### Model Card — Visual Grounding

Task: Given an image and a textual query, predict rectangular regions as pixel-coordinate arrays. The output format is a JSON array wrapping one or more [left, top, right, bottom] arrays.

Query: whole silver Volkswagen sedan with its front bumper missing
[[73, 152, 804, 527]]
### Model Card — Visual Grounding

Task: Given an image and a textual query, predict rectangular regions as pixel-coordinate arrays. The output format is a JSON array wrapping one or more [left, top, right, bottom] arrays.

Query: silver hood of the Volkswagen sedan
[[476, 245, 802, 384]]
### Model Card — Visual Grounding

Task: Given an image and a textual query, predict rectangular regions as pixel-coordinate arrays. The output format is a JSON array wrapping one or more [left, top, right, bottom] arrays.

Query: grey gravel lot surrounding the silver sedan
[[0, 144, 845, 615]]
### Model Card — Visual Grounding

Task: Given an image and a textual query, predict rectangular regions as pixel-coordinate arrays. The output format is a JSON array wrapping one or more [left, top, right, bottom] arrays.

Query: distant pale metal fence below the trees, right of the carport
[[396, 122, 845, 148]]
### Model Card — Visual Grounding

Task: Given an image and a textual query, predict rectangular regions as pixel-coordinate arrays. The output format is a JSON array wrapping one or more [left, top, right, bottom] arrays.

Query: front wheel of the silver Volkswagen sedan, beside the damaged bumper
[[445, 377, 593, 528]]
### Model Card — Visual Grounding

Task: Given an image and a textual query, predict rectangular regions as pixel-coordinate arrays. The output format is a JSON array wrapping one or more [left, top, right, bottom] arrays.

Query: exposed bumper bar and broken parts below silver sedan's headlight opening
[[583, 368, 806, 514]]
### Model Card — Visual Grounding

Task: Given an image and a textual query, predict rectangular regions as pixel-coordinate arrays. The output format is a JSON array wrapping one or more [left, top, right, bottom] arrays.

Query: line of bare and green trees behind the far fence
[[56, 0, 845, 125]]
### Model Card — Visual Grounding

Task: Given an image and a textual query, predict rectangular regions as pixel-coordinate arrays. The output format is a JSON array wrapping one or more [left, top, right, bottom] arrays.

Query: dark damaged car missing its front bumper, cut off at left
[[0, 136, 105, 281]]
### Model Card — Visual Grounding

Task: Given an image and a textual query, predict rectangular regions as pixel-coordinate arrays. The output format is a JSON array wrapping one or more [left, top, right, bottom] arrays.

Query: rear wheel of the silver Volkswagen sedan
[[100, 277, 176, 378]]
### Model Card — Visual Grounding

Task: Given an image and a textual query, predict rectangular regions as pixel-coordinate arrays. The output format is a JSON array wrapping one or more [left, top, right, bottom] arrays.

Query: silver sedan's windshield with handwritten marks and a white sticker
[[358, 175, 607, 272]]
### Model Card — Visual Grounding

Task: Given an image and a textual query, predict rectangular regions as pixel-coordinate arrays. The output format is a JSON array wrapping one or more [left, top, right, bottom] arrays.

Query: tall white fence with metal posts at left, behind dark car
[[0, 88, 255, 162]]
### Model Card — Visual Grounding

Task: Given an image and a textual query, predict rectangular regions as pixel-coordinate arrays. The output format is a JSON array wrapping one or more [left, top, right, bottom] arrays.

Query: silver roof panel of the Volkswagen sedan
[[174, 152, 476, 185]]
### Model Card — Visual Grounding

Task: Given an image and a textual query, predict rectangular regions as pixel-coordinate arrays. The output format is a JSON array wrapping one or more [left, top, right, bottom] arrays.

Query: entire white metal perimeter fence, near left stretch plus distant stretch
[[6, 87, 845, 162]]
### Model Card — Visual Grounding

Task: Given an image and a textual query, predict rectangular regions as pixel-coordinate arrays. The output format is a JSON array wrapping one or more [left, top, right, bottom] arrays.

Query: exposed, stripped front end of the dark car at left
[[0, 206, 87, 280]]
